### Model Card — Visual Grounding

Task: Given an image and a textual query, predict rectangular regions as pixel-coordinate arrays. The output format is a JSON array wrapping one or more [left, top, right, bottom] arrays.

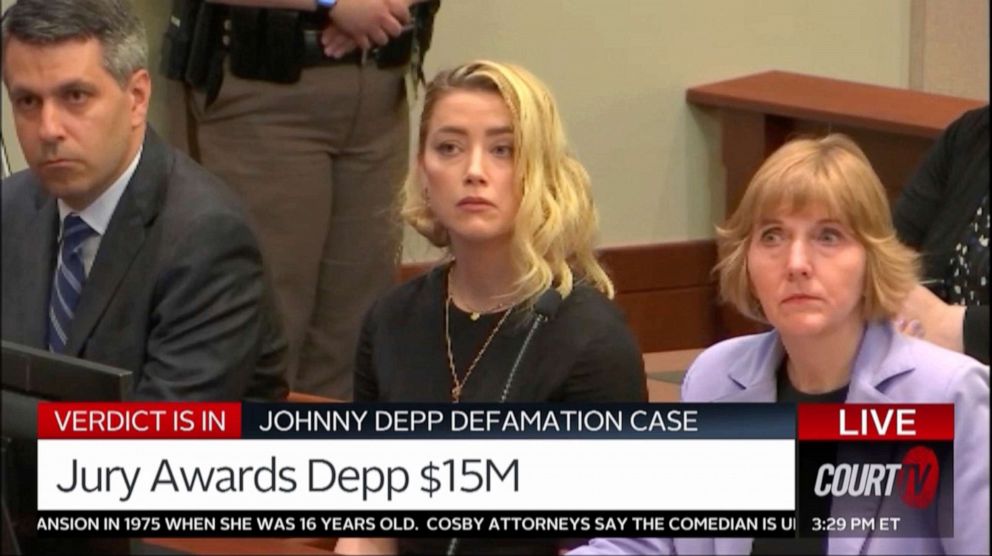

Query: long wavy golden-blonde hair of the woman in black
[[400, 60, 614, 304]]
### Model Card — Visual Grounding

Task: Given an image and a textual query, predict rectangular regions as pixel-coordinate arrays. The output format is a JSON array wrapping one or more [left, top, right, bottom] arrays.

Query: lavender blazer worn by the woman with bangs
[[568, 323, 989, 556]]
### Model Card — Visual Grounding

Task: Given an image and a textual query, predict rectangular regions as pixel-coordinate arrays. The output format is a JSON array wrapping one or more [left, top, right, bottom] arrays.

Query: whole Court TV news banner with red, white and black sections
[[37, 403, 953, 537]]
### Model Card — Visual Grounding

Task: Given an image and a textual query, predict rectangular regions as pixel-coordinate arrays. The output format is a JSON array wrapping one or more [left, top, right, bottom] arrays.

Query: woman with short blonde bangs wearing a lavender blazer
[[569, 135, 989, 555]]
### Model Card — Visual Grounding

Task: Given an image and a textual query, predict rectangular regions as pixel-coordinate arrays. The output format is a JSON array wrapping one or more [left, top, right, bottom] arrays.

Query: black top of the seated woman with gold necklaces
[[355, 266, 648, 554]]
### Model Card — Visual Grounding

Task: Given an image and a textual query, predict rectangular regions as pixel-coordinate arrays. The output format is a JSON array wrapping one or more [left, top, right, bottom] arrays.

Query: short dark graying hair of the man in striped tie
[[3, 0, 148, 87]]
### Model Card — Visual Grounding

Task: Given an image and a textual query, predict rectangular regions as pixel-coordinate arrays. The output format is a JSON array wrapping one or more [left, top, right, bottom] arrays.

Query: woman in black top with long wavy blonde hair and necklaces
[[339, 61, 647, 554]]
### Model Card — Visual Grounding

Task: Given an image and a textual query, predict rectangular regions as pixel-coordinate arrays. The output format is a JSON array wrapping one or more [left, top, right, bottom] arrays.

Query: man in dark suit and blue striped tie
[[2, 0, 286, 400]]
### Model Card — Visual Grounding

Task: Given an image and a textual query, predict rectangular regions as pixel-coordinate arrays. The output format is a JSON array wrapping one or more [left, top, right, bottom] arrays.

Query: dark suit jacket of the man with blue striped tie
[[2, 128, 287, 400]]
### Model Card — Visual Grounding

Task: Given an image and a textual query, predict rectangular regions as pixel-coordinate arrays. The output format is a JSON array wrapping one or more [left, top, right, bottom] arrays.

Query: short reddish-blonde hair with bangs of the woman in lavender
[[714, 133, 920, 322]]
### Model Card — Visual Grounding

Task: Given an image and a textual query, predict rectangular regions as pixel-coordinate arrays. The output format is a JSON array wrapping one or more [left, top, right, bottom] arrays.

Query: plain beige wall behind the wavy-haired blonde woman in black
[[411, 0, 910, 258]]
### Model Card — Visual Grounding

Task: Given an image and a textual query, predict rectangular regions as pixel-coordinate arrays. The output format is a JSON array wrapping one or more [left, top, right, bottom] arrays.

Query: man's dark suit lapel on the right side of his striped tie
[[65, 128, 171, 356]]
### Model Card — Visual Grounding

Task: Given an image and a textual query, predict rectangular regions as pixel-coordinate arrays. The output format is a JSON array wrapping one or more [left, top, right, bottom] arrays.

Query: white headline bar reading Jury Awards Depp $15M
[[38, 439, 795, 511]]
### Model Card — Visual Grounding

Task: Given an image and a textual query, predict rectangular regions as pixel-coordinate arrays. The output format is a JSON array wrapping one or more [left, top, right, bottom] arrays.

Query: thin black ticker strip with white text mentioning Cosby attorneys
[[38, 511, 796, 537]]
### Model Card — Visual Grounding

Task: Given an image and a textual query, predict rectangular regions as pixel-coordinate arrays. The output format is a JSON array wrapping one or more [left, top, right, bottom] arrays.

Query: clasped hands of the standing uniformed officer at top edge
[[324, 0, 410, 50]]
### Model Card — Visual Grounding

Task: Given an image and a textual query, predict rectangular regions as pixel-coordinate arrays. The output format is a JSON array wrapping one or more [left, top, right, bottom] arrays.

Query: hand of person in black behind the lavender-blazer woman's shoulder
[[895, 285, 965, 353]]
